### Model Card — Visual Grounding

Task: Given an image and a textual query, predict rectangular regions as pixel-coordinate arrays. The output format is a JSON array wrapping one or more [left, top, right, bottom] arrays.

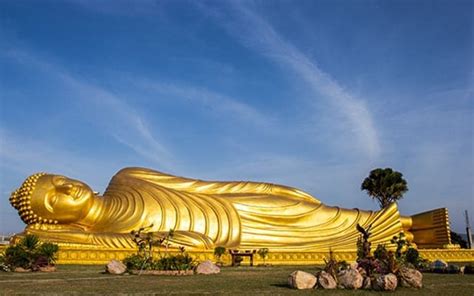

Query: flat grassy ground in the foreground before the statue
[[0, 265, 474, 296]]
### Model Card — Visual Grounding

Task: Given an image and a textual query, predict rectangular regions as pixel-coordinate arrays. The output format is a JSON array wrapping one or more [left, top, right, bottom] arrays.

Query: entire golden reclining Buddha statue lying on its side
[[10, 168, 450, 252]]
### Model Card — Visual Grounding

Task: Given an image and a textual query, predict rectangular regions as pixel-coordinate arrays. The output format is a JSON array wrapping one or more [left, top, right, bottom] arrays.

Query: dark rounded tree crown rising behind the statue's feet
[[361, 168, 408, 209]]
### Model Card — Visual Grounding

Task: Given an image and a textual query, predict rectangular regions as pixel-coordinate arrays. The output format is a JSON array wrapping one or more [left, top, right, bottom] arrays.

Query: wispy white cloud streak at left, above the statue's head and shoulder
[[6, 50, 173, 168]]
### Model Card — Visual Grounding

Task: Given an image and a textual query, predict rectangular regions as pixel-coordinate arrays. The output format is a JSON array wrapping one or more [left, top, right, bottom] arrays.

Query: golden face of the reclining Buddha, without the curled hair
[[31, 174, 94, 223]]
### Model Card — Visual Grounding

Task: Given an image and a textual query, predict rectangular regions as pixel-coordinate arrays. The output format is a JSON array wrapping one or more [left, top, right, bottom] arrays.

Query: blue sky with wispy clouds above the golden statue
[[0, 0, 474, 232]]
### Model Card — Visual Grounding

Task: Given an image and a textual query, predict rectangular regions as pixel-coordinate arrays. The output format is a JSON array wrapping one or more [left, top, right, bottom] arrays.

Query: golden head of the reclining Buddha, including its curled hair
[[10, 173, 94, 224]]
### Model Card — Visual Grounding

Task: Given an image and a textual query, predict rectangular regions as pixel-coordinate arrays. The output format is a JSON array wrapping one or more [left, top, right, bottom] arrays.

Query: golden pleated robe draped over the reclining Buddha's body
[[94, 168, 403, 251]]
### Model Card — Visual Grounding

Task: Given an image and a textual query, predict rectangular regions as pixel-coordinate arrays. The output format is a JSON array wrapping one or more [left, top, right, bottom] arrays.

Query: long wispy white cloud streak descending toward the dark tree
[[204, 1, 381, 159]]
